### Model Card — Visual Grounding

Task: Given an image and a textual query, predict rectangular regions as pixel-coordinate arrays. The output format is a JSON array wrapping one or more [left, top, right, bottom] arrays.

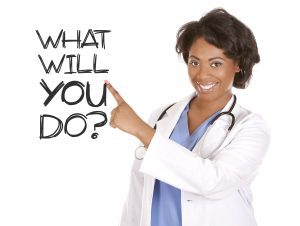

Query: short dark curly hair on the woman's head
[[175, 8, 260, 89]]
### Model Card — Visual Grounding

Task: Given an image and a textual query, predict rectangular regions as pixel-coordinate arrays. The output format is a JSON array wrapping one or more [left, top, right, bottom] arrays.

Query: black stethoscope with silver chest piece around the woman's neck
[[135, 94, 236, 160]]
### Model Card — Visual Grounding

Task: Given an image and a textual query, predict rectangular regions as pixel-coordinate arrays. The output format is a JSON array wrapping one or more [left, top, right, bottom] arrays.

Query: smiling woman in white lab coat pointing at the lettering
[[106, 9, 269, 226]]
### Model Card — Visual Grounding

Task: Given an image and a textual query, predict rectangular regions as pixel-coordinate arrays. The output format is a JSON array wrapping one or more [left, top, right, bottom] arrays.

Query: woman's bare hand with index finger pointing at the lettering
[[105, 81, 154, 146]]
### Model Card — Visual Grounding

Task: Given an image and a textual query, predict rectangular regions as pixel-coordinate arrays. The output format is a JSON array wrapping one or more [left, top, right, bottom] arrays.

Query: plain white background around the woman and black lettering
[[0, 0, 300, 226]]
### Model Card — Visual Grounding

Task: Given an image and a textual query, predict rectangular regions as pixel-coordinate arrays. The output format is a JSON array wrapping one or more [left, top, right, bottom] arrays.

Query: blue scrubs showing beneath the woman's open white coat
[[151, 104, 219, 226]]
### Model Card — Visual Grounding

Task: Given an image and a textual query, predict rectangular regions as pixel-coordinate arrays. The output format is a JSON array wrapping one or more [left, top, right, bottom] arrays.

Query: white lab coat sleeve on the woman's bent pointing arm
[[140, 114, 270, 199]]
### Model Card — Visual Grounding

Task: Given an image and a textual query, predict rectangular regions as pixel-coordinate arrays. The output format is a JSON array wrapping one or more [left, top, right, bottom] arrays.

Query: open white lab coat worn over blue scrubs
[[121, 93, 269, 226]]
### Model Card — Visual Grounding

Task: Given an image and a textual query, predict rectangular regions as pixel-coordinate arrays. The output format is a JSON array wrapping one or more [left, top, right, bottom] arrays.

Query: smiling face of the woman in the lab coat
[[188, 38, 240, 100]]
